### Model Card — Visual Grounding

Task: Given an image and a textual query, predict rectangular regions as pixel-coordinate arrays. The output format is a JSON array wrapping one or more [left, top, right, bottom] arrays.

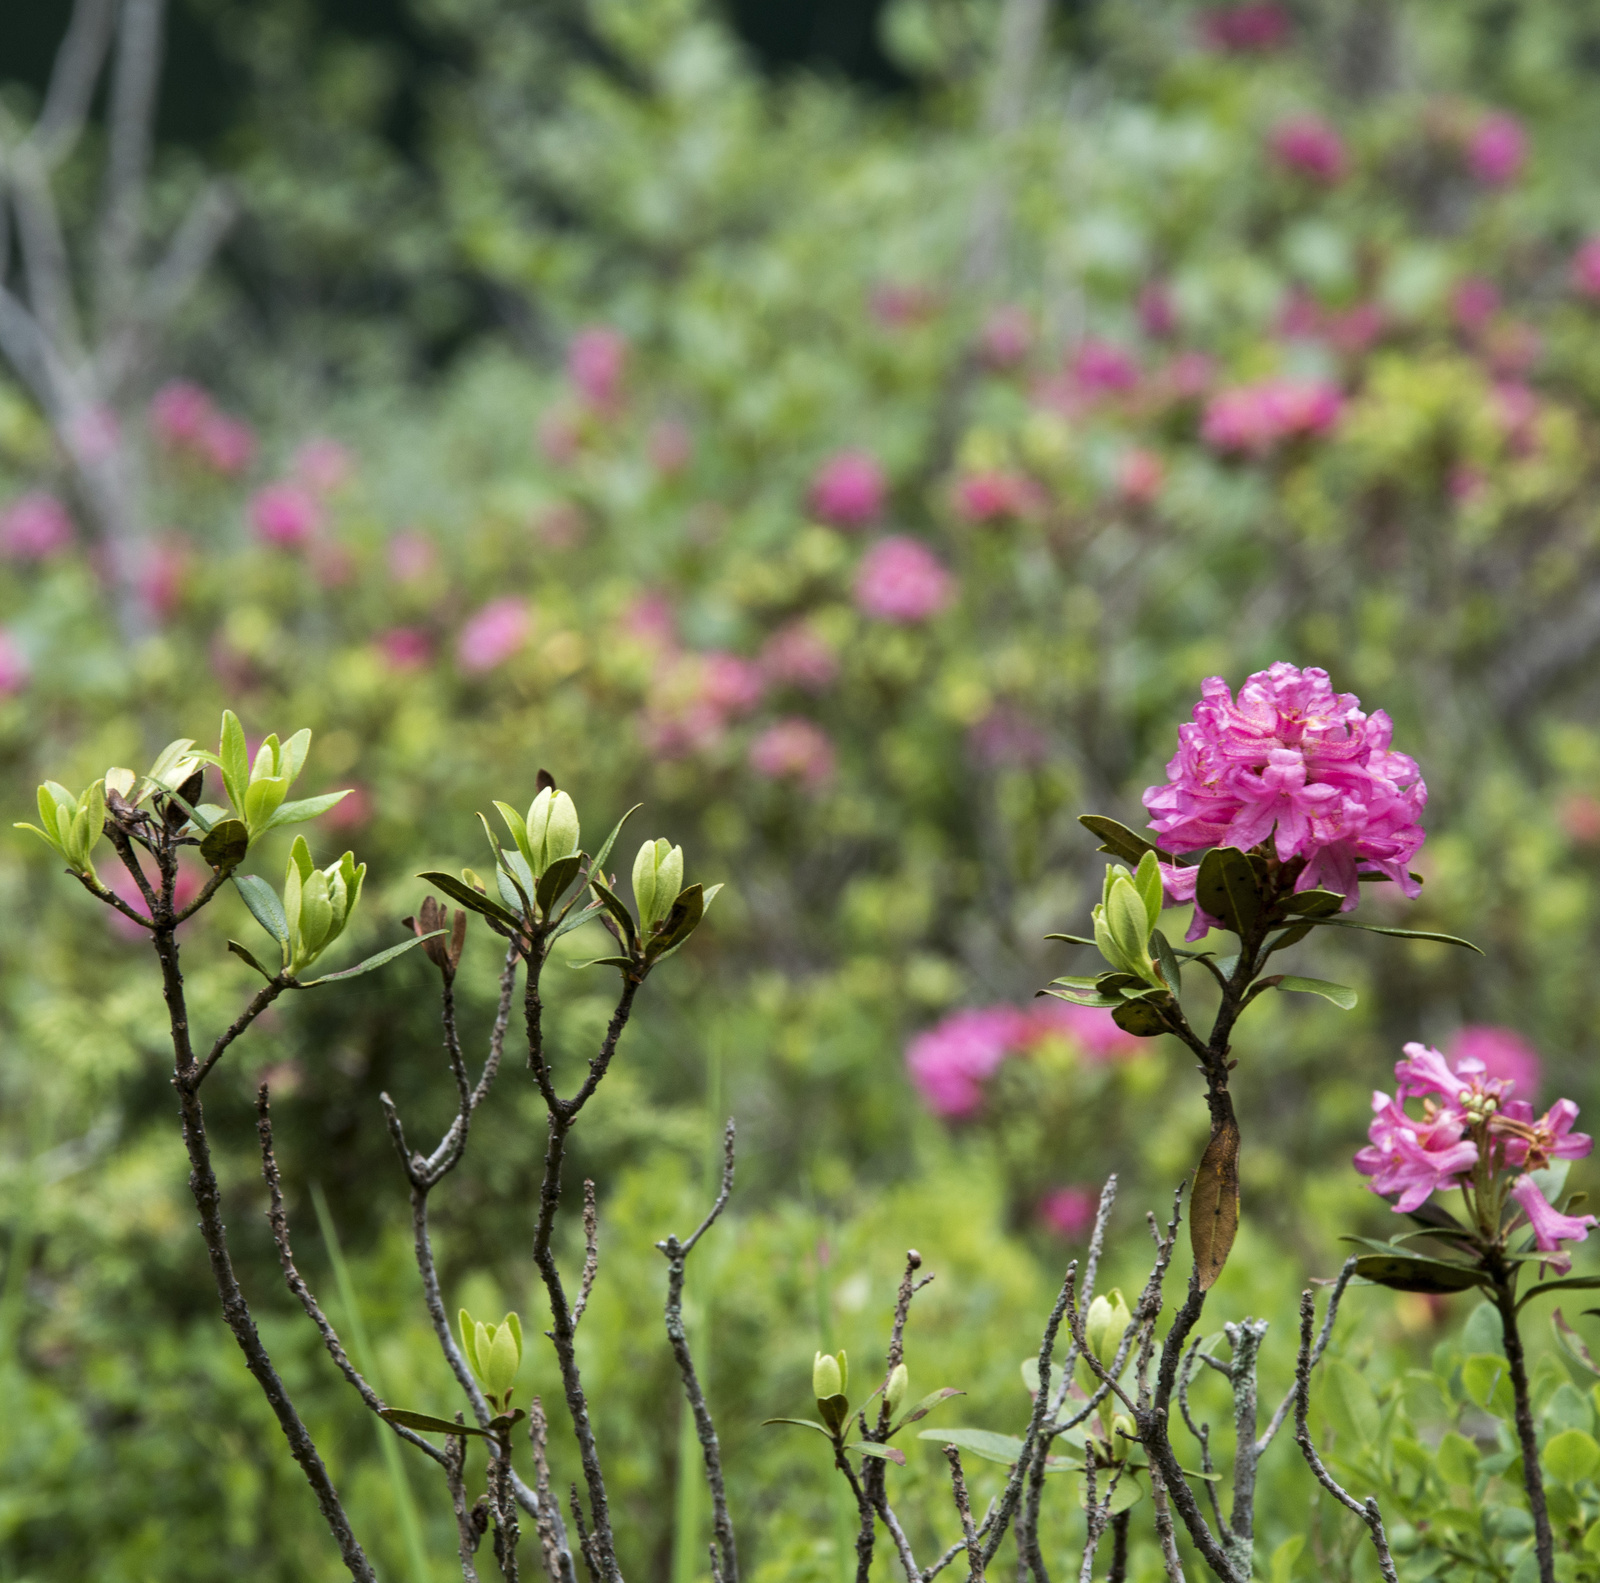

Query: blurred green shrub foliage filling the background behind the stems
[[9, 0, 1600, 1583]]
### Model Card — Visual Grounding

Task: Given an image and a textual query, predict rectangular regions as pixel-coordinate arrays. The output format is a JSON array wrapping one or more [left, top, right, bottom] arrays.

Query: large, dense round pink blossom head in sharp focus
[[1144, 661, 1427, 921]]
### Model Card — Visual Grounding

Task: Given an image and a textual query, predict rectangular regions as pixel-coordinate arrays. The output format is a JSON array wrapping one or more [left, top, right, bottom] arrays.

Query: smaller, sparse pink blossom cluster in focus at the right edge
[[1355, 1044, 1597, 1272]]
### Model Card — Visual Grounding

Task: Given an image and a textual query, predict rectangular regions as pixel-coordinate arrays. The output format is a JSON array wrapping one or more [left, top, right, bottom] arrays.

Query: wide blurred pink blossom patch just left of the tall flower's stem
[[906, 1000, 1139, 1120]]
